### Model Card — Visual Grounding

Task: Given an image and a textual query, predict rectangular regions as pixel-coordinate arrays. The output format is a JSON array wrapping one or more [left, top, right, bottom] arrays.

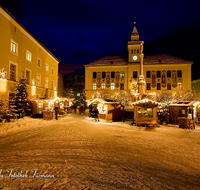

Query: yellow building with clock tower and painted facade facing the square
[[85, 26, 192, 99]]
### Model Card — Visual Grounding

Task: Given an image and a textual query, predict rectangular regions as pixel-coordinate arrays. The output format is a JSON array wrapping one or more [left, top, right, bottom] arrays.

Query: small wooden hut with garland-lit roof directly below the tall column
[[132, 99, 161, 127]]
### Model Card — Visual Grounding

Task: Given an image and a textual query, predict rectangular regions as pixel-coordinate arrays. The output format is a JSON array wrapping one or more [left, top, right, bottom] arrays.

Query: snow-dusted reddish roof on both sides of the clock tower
[[85, 55, 193, 67]]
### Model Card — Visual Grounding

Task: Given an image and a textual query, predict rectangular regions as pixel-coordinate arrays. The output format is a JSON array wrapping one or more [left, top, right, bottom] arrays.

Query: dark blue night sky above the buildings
[[0, 0, 200, 79]]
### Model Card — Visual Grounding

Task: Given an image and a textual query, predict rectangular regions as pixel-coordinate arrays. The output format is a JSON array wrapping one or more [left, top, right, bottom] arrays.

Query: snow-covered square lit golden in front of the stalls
[[0, 110, 200, 190]]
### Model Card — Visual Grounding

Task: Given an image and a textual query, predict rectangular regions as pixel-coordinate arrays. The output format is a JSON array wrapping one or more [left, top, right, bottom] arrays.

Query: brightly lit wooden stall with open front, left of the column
[[90, 98, 122, 122]]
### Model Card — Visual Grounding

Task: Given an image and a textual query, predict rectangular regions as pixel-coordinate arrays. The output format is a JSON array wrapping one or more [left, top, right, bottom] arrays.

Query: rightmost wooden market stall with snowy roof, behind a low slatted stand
[[169, 101, 200, 123]]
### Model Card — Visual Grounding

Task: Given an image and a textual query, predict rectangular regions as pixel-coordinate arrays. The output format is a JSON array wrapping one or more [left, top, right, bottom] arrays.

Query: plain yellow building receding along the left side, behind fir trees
[[0, 6, 59, 100]]
